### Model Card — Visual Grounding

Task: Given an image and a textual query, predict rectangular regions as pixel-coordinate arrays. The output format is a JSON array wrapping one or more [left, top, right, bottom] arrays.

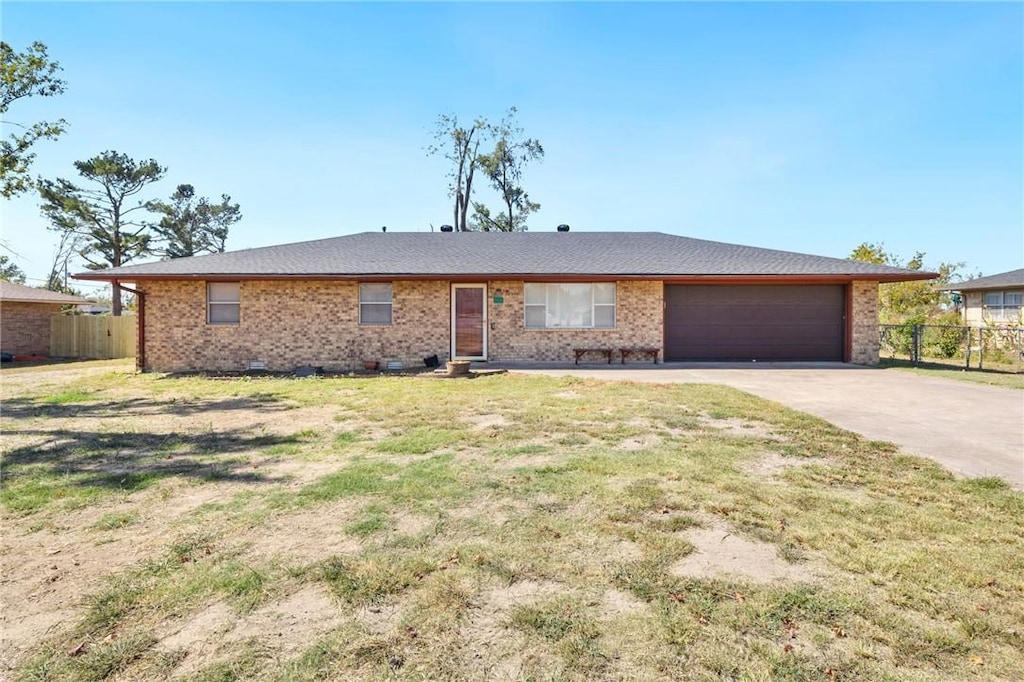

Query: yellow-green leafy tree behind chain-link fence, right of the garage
[[850, 242, 965, 325]]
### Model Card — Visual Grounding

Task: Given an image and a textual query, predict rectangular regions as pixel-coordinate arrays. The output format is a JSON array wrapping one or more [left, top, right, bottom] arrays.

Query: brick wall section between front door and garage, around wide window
[[487, 282, 663, 363]]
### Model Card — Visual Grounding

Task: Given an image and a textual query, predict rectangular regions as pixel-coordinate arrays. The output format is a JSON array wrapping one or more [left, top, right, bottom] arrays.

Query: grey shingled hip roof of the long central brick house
[[75, 232, 936, 282]]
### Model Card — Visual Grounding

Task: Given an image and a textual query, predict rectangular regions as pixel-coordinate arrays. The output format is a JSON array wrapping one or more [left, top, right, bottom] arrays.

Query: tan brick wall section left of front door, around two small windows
[[142, 281, 450, 372]]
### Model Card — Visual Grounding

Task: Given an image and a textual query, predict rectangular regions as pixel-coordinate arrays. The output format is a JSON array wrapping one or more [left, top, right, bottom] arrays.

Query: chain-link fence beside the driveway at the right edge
[[879, 323, 1024, 372]]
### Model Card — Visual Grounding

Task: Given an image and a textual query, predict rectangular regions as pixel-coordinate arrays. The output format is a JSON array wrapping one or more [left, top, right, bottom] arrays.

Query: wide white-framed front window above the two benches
[[524, 282, 615, 329]]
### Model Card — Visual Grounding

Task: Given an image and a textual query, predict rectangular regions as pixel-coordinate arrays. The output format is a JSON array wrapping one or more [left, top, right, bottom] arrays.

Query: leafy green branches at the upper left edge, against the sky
[[0, 42, 68, 199]]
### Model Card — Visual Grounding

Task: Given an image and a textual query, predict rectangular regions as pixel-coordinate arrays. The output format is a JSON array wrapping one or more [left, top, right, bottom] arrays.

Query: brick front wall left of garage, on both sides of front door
[[136, 281, 662, 372]]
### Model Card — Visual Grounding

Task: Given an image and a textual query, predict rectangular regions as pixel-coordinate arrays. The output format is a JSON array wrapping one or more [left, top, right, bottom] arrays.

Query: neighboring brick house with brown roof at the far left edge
[[0, 282, 88, 355]]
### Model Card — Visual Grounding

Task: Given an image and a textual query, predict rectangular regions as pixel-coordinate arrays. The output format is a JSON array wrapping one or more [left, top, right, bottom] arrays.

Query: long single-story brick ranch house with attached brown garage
[[75, 231, 935, 372]]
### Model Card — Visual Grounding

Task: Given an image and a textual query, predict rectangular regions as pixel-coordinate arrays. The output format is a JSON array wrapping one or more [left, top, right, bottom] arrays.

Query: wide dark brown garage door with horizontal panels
[[665, 285, 846, 360]]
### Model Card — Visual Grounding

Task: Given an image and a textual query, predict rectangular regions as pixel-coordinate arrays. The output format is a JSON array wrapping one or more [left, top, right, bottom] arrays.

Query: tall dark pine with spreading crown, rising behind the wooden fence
[[39, 152, 167, 315]]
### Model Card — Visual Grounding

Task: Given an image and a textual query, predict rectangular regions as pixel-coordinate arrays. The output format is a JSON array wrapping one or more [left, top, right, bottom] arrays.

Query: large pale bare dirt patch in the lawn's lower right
[[671, 523, 816, 583]]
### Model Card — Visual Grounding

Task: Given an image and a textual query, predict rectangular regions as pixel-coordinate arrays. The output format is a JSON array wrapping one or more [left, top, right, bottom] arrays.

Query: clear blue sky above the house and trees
[[0, 1, 1024, 291]]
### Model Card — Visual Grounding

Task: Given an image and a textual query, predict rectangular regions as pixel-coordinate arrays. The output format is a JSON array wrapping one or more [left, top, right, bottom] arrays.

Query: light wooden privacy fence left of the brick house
[[50, 315, 138, 359]]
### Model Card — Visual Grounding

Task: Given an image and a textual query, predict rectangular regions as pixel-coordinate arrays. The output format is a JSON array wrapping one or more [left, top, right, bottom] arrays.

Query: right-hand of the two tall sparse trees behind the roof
[[473, 106, 544, 232]]
